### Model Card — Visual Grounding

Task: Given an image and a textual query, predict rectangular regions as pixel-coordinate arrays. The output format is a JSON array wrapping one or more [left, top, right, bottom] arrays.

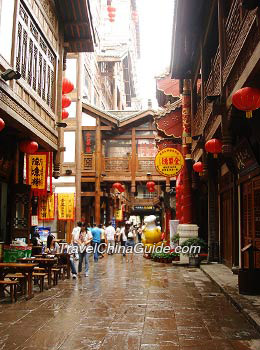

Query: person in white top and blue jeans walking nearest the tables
[[77, 226, 92, 277]]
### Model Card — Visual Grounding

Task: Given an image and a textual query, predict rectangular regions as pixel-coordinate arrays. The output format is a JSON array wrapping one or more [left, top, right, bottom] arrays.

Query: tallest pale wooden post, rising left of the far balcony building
[[75, 53, 84, 221]]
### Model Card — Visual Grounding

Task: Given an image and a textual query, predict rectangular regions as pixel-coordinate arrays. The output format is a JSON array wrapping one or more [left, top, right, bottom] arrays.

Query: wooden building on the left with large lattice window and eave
[[0, 0, 93, 241]]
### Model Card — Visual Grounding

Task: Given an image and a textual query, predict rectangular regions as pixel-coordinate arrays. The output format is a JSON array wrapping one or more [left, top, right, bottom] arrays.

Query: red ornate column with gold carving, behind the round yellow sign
[[182, 79, 192, 224]]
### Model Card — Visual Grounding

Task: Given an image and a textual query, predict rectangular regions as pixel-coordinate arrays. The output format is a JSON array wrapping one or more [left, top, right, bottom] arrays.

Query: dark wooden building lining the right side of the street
[[171, 0, 260, 267]]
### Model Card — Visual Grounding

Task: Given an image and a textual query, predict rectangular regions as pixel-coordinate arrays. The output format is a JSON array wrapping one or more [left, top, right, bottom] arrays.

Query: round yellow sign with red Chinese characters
[[155, 148, 184, 177]]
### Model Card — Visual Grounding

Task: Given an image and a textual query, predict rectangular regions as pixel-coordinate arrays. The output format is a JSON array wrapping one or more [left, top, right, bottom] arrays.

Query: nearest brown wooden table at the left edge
[[0, 262, 38, 299]]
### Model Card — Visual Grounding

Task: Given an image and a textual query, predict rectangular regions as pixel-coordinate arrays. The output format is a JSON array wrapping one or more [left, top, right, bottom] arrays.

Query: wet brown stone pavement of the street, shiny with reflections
[[0, 255, 260, 350]]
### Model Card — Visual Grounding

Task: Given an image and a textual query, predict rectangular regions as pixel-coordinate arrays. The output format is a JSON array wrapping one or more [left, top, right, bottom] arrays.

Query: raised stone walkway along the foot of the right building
[[201, 263, 260, 334]]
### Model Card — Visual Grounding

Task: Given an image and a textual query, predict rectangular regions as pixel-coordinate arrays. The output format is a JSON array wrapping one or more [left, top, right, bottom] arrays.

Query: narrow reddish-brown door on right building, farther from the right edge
[[220, 189, 233, 267]]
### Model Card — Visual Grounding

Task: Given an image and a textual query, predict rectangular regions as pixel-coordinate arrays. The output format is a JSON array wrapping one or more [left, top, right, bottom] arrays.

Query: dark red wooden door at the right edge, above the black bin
[[241, 177, 260, 268]]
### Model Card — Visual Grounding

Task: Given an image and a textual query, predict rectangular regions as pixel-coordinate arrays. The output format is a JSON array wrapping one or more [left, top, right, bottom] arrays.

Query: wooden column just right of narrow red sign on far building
[[95, 118, 102, 225]]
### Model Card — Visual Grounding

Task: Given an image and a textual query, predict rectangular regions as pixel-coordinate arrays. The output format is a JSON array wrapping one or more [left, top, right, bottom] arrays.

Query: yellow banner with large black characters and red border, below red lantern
[[26, 152, 49, 196]]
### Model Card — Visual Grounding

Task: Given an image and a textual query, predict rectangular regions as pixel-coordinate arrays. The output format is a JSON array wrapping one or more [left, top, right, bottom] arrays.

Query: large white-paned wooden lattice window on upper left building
[[16, 3, 56, 110]]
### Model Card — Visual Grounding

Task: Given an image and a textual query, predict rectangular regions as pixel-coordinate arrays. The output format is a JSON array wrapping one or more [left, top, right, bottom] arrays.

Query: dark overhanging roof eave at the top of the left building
[[55, 0, 95, 52]]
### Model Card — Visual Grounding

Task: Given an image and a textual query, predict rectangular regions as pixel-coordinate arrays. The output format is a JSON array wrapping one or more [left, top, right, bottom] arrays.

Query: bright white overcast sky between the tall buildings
[[136, 0, 174, 106]]
